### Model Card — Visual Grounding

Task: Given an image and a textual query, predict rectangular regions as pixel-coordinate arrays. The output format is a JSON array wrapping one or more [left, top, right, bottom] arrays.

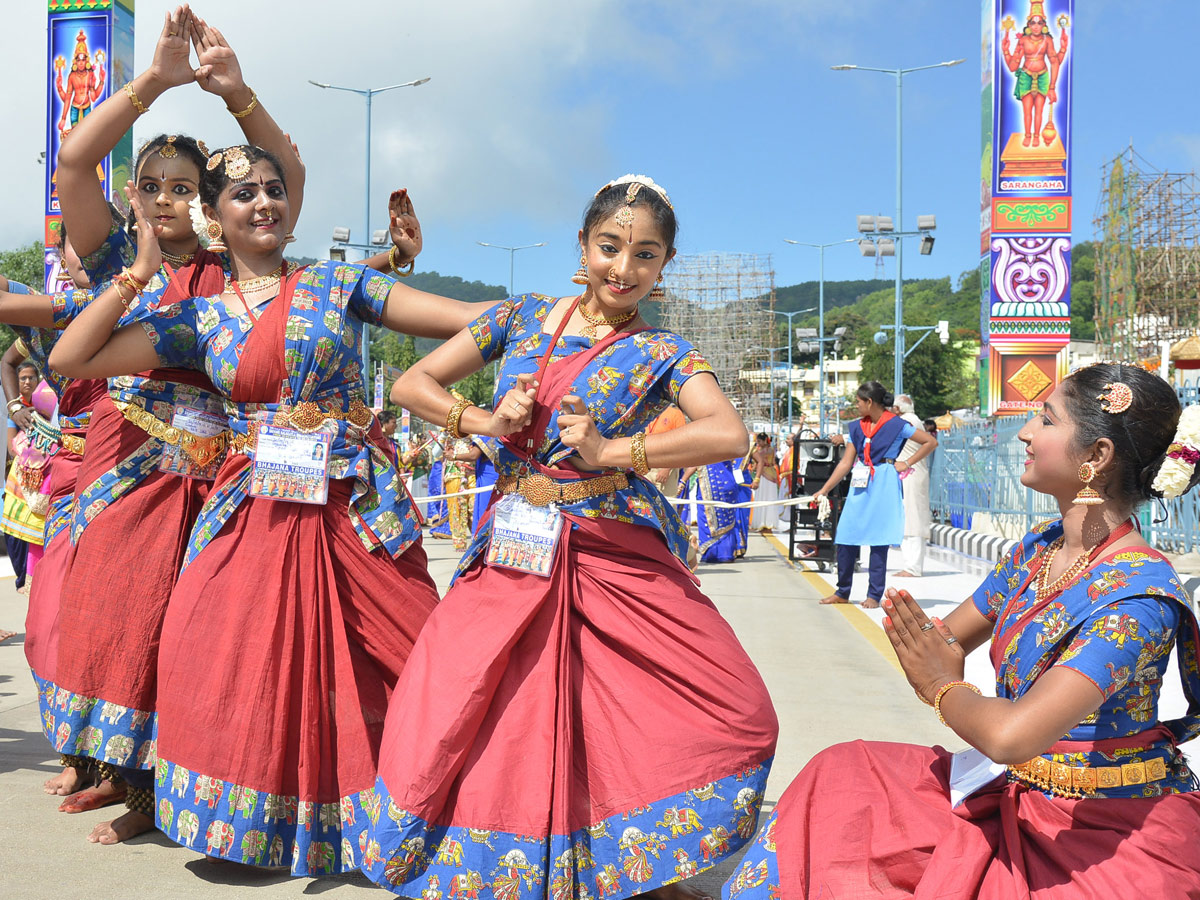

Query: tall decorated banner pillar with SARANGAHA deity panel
[[984, 0, 1074, 415]]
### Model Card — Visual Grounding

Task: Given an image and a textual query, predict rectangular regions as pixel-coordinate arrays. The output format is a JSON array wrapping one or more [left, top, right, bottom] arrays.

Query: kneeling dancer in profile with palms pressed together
[[726, 364, 1200, 900]]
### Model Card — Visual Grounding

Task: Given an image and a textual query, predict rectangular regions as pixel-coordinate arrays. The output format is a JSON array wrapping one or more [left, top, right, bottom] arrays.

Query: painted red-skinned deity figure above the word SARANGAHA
[[1000, 0, 1069, 146]]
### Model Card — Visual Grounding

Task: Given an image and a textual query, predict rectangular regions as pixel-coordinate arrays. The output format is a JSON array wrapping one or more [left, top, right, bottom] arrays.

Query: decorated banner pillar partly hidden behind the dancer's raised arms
[[44, 0, 133, 292]]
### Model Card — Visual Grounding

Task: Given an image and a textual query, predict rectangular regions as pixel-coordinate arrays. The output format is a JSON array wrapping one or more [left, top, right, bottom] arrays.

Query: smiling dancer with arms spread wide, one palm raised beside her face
[[52, 130, 499, 875]]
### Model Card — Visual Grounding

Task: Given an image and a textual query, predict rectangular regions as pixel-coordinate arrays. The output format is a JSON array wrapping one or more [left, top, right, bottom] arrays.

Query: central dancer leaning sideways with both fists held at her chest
[[362, 176, 776, 900]]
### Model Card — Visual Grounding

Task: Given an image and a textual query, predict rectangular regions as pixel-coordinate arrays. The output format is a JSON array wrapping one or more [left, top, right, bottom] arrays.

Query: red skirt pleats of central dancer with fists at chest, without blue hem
[[379, 511, 776, 836]]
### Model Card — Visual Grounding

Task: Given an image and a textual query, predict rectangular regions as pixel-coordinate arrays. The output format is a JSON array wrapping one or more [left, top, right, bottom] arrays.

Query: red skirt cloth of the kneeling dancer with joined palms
[[768, 740, 1200, 900]]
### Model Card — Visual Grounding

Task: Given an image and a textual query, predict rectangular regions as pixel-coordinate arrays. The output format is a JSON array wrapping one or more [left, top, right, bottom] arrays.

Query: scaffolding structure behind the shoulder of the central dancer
[[661, 253, 779, 421]]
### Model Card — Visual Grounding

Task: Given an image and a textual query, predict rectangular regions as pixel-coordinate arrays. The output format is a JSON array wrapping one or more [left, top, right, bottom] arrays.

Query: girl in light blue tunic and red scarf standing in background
[[812, 382, 937, 610]]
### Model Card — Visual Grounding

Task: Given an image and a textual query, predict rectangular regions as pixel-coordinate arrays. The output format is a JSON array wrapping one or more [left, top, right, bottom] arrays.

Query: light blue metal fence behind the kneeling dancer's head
[[929, 385, 1200, 553]]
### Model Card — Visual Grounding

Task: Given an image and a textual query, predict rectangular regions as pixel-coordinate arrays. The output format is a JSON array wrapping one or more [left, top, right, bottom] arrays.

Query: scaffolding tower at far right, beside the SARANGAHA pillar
[[1093, 144, 1200, 361]]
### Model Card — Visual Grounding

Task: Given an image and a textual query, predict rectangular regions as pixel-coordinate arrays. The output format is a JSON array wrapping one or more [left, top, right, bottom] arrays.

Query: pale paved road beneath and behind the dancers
[[0, 535, 958, 900]]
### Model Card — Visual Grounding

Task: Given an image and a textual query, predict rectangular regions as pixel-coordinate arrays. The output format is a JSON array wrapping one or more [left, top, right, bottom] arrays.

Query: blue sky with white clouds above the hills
[[0, 0, 1200, 303]]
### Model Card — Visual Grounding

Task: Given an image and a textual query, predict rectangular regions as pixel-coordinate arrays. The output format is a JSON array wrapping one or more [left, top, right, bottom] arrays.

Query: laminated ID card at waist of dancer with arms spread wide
[[250, 425, 334, 504]]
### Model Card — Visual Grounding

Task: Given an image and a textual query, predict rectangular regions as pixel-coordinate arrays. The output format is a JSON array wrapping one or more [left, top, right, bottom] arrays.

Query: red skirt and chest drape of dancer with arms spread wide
[[158, 292, 437, 806]]
